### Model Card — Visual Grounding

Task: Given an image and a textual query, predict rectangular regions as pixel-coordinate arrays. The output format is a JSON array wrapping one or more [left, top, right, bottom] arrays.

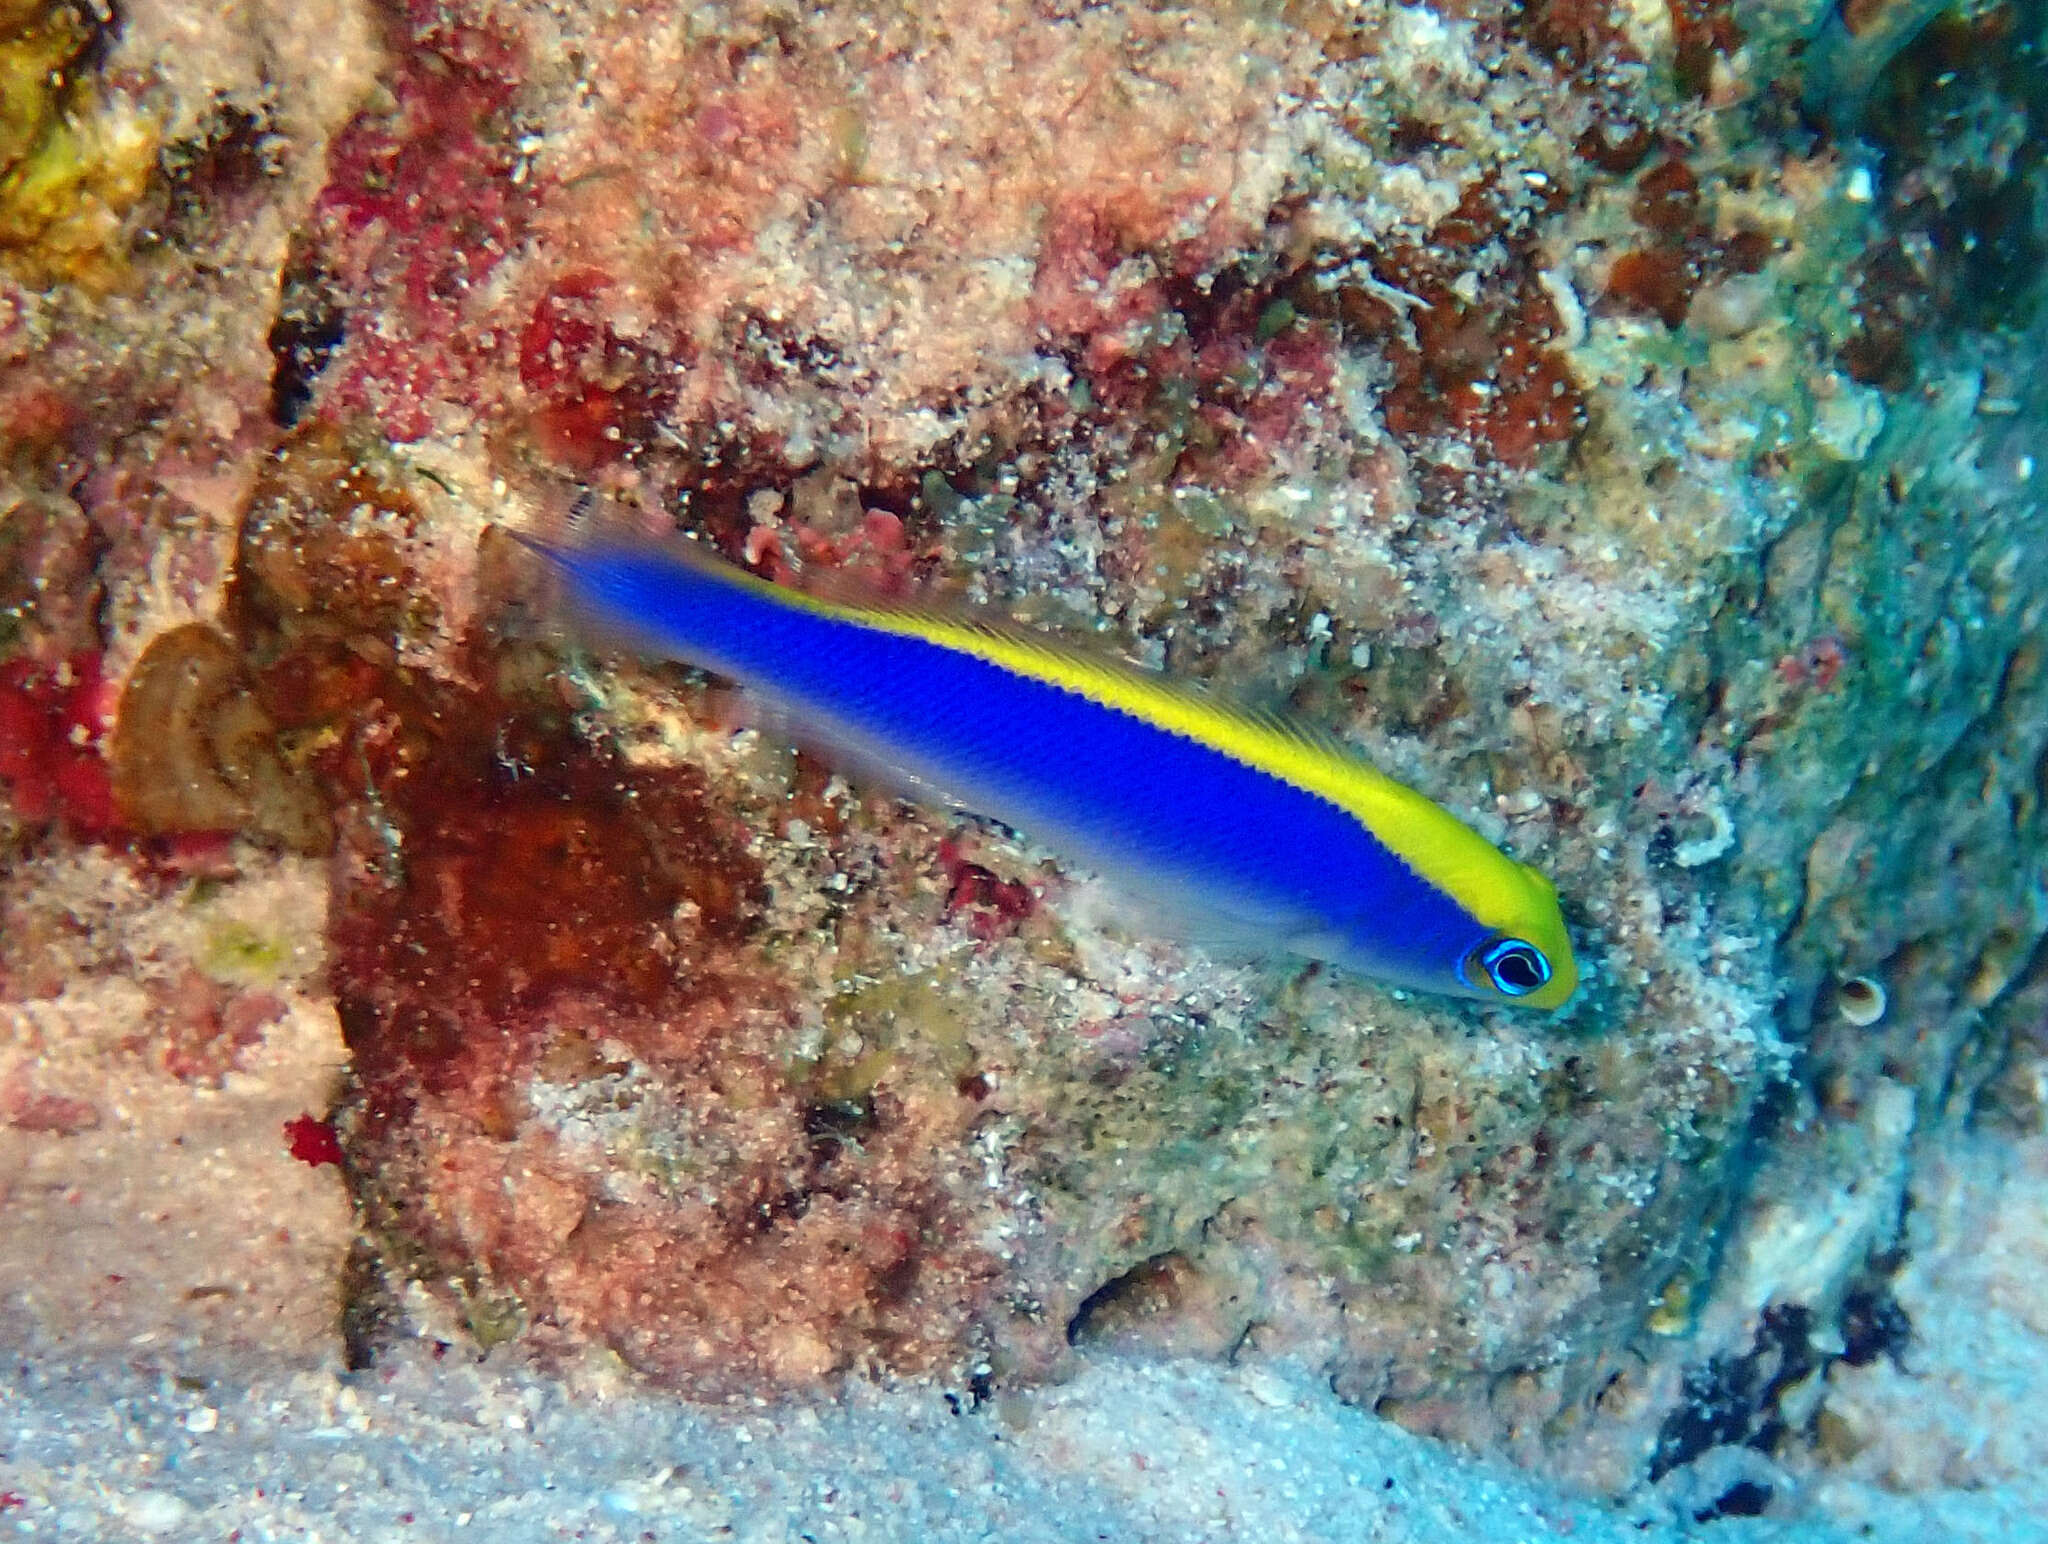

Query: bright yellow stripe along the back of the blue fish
[[719, 567, 1550, 928]]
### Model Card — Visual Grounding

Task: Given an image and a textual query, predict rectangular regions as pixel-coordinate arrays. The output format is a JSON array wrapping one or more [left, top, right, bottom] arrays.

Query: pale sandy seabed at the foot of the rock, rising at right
[[0, 1139, 2048, 1544]]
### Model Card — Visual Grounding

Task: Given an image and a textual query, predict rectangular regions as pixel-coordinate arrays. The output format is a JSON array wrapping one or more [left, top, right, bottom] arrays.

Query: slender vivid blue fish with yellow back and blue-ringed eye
[[526, 541, 1577, 1007]]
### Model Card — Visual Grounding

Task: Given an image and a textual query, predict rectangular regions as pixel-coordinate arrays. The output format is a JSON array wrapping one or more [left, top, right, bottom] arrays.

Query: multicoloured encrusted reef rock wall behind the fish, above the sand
[[0, 0, 2048, 1491]]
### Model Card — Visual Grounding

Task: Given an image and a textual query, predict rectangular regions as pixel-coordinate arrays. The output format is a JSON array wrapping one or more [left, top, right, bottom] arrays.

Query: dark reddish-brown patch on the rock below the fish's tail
[[330, 655, 758, 1124]]
